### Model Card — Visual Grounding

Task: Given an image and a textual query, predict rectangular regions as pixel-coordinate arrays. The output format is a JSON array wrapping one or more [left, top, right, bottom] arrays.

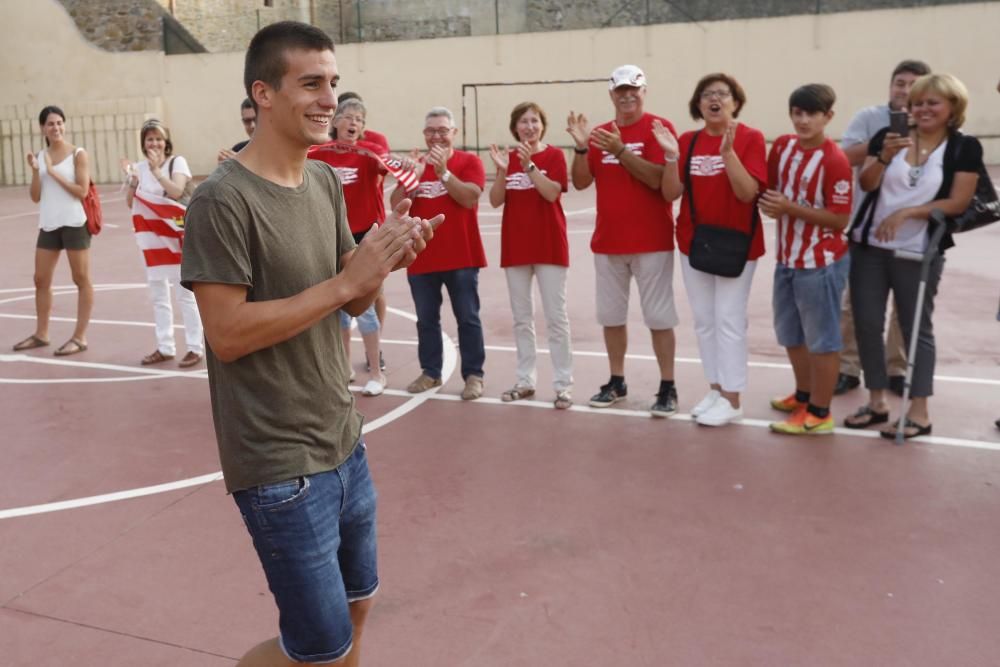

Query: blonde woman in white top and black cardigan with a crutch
[[844, 74, 983, 438]]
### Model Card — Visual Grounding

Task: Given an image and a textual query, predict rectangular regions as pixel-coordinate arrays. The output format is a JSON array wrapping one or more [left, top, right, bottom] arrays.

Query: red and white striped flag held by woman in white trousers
[[132, 192, 186, 279]]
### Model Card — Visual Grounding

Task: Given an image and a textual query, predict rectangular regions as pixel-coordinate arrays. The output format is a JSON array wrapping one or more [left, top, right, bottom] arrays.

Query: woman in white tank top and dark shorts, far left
[[14, 106, 94, 356]]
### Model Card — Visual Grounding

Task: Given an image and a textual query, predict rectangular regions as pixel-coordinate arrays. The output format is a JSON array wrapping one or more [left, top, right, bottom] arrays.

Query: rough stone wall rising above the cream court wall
[[60, 0, 984, 52]]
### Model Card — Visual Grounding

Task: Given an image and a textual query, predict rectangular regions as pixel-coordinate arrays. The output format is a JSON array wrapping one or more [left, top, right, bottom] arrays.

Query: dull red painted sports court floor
[[0, 179, 1000, 667]]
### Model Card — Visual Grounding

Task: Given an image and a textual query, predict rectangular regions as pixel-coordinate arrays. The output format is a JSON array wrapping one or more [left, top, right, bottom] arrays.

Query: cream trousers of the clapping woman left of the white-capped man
[[504, 264, 573, 392]]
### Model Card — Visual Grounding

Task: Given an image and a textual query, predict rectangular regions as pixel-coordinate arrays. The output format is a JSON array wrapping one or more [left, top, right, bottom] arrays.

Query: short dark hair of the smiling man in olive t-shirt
[[243, 21, 333, 111]]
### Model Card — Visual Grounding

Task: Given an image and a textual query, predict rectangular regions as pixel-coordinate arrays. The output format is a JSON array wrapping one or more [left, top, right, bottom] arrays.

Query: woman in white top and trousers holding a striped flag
[[125, 119, 205, 368]]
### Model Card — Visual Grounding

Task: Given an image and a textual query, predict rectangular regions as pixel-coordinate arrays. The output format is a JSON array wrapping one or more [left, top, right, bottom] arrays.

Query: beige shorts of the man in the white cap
[[594, 251, 679, 331]]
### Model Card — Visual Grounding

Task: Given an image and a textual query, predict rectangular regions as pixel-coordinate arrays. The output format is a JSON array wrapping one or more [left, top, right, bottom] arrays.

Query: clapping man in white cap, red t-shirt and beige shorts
[[566, 65, 678, 417]]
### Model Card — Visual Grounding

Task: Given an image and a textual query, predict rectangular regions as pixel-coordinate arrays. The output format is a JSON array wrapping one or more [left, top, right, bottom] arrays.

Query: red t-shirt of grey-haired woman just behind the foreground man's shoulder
[[308, 142, 385, 234]]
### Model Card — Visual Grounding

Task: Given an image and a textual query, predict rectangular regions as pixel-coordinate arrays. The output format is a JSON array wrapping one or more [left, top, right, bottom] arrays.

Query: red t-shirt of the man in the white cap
[[587, 113, 677, 255]]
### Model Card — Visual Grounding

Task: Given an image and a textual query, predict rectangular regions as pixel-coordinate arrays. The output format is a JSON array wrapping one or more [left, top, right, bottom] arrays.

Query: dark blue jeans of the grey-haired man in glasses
[[409, 267, 486, 379]]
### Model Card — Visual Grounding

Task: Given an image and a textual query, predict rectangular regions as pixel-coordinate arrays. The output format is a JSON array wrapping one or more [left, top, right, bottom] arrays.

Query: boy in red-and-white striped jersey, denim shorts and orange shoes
[[760, 83, 853, 435]]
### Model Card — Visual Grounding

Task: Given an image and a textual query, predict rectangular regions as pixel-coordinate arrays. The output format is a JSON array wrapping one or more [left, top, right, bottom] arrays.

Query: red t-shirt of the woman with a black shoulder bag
[[677, 123, 767, 259]]
